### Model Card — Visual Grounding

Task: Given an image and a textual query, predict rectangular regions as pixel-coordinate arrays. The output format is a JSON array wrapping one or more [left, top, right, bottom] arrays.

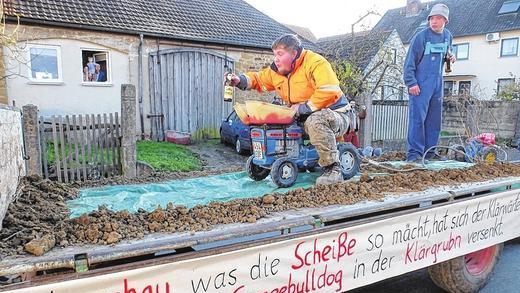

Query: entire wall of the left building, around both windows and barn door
[[4, 25, 272, 134]]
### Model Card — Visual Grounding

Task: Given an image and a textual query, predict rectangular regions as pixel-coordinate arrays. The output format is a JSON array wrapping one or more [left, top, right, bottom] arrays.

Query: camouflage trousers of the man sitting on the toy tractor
[[304, 108, 350, 167]]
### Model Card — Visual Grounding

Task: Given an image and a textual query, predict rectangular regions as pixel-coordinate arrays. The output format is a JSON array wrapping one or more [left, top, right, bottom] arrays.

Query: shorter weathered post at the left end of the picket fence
[[22, 104, 42, 176]]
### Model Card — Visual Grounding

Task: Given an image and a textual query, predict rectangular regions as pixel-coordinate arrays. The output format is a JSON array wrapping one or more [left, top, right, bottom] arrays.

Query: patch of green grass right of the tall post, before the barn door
[[137, 140, 202, 171]]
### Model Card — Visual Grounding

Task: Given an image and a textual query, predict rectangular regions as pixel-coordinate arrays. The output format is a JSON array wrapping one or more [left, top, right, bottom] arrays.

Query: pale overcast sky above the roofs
[[245, 0, 434, 38]]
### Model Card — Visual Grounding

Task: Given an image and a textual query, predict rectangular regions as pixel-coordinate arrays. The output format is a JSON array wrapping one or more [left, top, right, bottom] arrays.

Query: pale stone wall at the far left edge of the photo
[[0, 106, 25, 229]]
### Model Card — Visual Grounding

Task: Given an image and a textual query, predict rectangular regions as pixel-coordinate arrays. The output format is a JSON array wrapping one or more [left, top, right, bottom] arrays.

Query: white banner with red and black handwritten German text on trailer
[[7, 190, 520, 293]]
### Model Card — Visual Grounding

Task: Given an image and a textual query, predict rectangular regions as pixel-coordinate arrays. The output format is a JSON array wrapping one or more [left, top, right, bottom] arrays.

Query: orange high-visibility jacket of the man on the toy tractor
[[241, 50, 343, 111]]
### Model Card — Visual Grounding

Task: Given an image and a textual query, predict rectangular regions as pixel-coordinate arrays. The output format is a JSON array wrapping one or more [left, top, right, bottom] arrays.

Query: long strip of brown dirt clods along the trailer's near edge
[[0, 163, 520, 255]]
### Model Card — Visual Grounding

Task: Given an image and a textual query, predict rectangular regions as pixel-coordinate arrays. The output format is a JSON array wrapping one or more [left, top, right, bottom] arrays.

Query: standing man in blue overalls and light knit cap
[[404, 4, 455, 162]]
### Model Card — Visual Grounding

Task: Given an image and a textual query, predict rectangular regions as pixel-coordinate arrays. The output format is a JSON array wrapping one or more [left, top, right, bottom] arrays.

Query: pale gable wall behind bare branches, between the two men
[[365, 31, 408, 100]]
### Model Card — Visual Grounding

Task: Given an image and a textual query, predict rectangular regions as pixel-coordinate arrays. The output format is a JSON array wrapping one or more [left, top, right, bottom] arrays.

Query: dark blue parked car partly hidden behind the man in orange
[[220, 110, 251, 154]]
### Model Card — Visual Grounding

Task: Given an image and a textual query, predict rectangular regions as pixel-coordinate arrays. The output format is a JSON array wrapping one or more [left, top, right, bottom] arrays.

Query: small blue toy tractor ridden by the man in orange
[[246, 124, 361, 187]]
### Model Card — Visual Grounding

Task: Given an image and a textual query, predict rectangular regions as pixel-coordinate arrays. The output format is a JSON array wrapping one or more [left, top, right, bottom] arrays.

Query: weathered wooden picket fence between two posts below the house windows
[[39, 113, 121, 182]]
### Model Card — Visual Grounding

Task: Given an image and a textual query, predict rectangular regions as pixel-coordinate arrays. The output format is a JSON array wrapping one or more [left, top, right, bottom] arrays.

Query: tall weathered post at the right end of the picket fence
[[121, 84, 137, 178]]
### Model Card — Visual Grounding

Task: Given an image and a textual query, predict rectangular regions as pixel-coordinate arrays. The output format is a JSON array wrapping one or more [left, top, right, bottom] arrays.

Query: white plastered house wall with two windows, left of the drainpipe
[[4, 26, 135, 116]]
